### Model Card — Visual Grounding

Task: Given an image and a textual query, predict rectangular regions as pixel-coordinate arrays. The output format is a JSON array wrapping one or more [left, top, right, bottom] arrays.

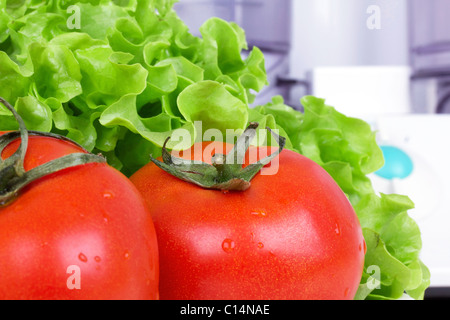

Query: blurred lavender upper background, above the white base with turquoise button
[[175, 0, 450, 114]]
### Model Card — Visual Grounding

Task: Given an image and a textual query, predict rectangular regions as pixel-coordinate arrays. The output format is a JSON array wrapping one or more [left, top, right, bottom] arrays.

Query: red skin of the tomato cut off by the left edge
[[0, 136, 159, 300]]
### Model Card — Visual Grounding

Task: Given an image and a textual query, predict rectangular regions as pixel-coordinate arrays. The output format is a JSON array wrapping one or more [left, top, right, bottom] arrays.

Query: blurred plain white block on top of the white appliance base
[[310, 65, 411, 118]]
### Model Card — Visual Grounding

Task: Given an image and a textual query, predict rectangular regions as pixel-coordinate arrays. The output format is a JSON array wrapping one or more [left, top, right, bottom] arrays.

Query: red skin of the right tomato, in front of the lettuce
[[130, 142, 365, 300]]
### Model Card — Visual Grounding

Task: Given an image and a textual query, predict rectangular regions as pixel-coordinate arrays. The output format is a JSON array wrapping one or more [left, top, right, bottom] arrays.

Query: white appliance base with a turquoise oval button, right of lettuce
[[371, 114, 450, 290]]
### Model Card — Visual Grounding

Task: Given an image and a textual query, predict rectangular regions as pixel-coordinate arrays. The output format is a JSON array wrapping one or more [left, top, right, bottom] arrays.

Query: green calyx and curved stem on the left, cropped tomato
[[0, 97, 106, 207]]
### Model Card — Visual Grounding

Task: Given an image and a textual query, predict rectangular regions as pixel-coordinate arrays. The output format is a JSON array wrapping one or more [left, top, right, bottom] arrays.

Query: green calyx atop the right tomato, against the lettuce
[[150, 122, 286, 191]]
